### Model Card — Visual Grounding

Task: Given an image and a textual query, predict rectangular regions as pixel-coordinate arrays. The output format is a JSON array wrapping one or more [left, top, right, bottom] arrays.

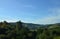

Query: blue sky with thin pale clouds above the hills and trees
[[0, 0, 60, 24]]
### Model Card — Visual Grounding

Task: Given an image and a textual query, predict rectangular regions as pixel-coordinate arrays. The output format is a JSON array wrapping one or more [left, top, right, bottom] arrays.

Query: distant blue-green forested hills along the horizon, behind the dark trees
[[10, 22, 60, 30]]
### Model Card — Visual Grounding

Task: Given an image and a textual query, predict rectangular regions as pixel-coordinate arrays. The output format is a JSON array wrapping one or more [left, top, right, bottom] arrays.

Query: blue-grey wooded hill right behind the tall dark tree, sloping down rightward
[[10, 22, 45, 30]]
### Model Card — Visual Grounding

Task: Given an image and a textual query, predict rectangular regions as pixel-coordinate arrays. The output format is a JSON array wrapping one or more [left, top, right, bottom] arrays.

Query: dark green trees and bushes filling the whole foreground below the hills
[[0, 21, 60, 39]]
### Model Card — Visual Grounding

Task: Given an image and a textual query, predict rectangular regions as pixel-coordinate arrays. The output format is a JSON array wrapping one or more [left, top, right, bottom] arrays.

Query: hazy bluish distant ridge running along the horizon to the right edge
[[10, 23, 60, 30]]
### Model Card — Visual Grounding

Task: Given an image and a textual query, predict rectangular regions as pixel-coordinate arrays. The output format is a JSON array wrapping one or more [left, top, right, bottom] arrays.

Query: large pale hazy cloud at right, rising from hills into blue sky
[[35, 8, 60, 24]]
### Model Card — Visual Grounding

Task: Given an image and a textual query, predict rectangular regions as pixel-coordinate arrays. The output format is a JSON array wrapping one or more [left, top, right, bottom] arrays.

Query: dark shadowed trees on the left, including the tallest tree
[[0, 21, 36, 39]]
